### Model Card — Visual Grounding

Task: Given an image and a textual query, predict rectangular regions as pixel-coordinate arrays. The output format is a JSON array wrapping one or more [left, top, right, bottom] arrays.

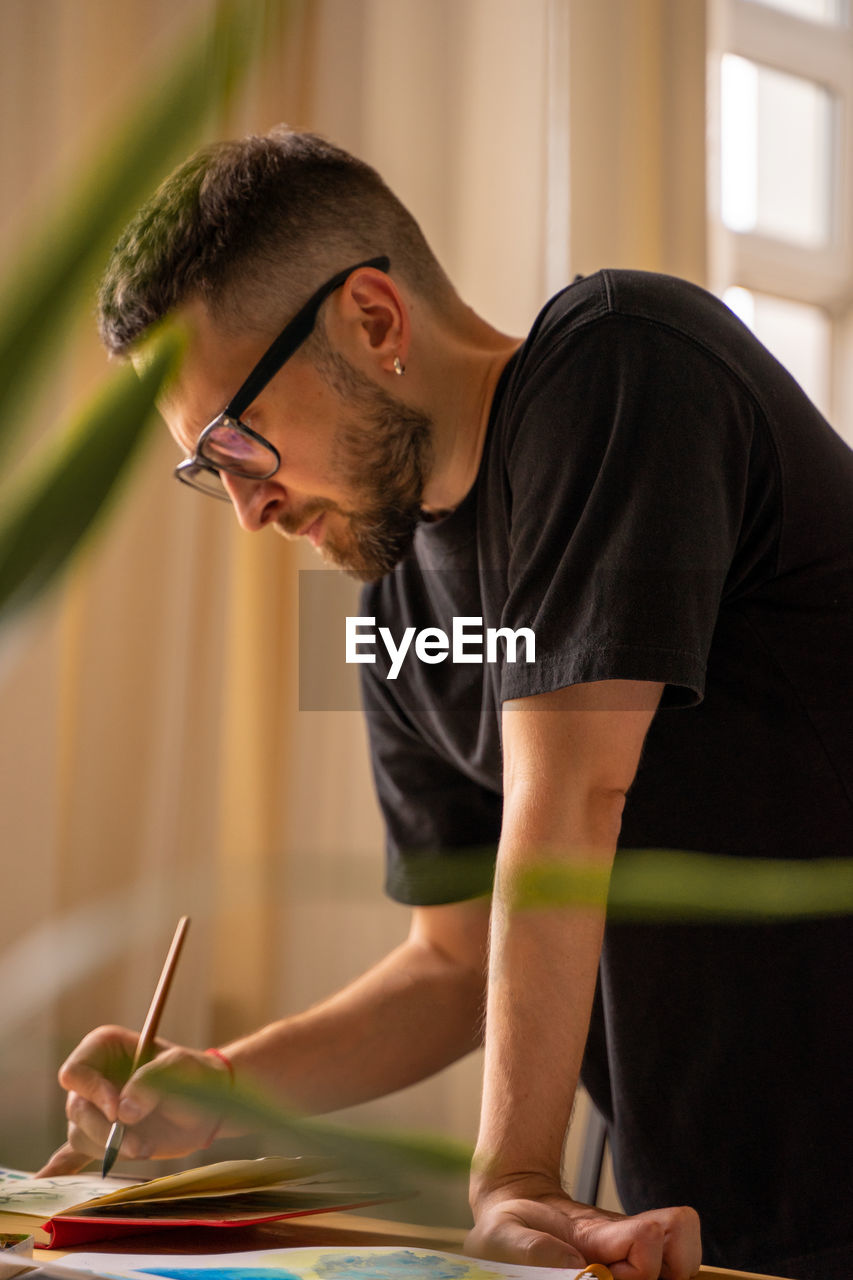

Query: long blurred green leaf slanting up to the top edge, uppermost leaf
[[0, 0, 298, 448]]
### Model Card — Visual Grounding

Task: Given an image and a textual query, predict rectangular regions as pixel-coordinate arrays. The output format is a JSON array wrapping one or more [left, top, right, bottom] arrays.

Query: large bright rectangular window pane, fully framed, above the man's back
[[721, 54, 834, 248]]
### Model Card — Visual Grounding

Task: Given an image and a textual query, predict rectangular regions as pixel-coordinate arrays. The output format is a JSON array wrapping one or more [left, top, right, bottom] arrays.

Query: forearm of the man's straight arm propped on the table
[[474, 792, 622, 1197]]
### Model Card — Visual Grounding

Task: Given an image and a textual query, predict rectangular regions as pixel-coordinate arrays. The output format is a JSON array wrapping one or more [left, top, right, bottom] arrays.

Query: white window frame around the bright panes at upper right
[[708, 0, 853, 443]]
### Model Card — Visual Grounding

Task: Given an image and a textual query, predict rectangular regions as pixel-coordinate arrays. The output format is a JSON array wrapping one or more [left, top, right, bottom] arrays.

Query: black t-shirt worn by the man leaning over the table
[[361, 271, 853, 1275]]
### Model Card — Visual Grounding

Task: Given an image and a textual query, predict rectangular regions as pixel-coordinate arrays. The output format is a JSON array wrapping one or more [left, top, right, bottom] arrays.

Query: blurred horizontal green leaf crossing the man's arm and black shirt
[[512, 849, 853, 923]]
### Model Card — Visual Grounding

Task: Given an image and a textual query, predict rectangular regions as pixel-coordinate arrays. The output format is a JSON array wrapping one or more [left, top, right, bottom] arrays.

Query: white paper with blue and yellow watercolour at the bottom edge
[[33, 1245, 612, 1280]]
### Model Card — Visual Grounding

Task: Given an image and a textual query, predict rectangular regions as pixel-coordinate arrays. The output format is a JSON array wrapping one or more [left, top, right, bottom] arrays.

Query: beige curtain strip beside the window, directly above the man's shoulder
[[569, 0, 707, 284]]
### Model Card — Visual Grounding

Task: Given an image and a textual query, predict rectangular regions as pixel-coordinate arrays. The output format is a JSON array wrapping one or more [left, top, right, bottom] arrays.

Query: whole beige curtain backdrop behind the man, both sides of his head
[[0, 0, 704, 1198]]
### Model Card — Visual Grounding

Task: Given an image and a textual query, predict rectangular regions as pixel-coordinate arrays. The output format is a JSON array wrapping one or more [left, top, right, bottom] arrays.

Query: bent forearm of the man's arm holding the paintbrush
[[217, 906, 487, 1112]]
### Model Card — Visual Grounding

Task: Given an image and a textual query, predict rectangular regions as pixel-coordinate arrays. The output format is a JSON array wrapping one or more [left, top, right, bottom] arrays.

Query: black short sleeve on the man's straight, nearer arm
[[501, 314, 754, 705]]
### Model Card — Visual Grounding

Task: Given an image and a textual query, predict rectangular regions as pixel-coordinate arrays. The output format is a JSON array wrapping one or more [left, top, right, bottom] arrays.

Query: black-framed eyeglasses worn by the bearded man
[[174, 256, 391, 502]]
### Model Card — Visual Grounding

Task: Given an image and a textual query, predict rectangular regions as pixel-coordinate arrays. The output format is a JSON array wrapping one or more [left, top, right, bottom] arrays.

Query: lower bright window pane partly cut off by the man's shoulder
[[722, 288, 831, 417]]
